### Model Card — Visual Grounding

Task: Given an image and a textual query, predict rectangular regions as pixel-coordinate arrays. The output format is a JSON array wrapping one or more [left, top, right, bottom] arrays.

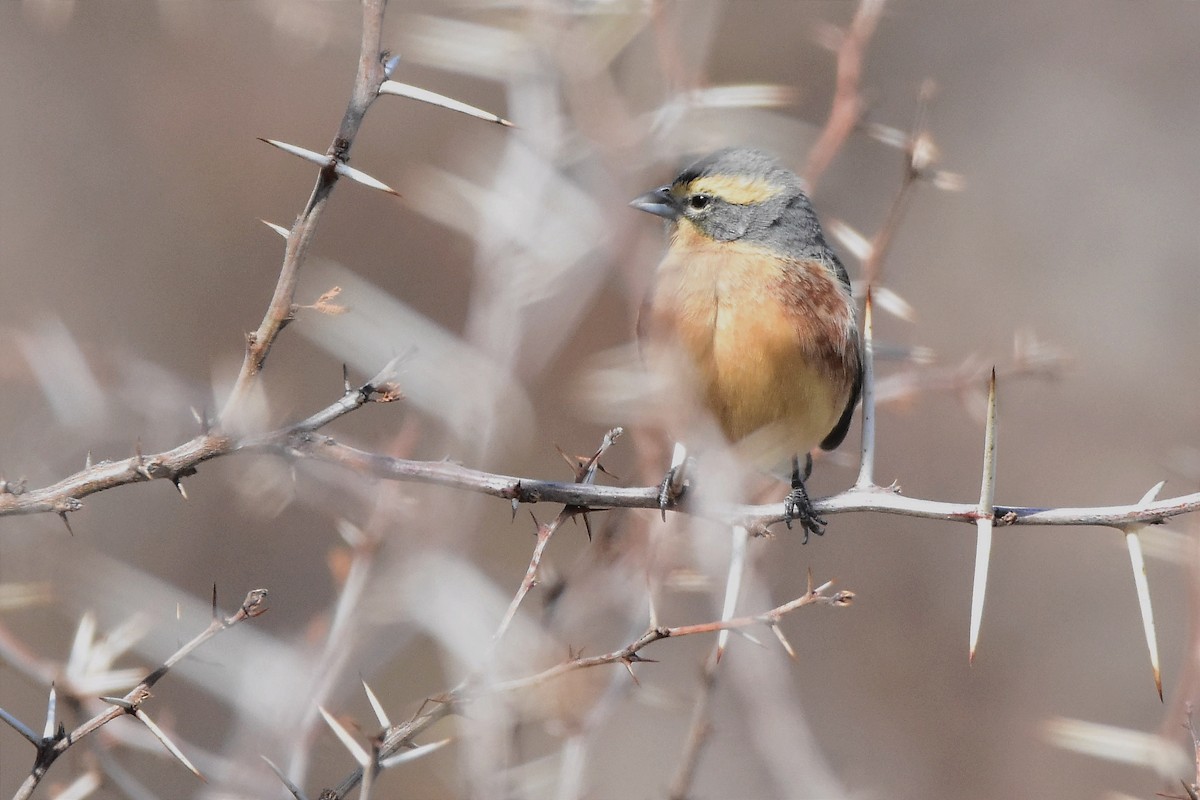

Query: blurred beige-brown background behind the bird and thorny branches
[[0, 0, 1200, 799]]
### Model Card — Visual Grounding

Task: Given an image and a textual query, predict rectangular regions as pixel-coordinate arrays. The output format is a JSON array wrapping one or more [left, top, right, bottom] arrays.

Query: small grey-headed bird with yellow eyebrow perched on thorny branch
[[630, 148, 863, 542]]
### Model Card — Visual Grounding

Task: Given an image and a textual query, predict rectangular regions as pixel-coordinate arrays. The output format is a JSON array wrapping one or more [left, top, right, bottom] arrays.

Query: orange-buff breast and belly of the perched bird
[[647, 221, 857, 465]]
